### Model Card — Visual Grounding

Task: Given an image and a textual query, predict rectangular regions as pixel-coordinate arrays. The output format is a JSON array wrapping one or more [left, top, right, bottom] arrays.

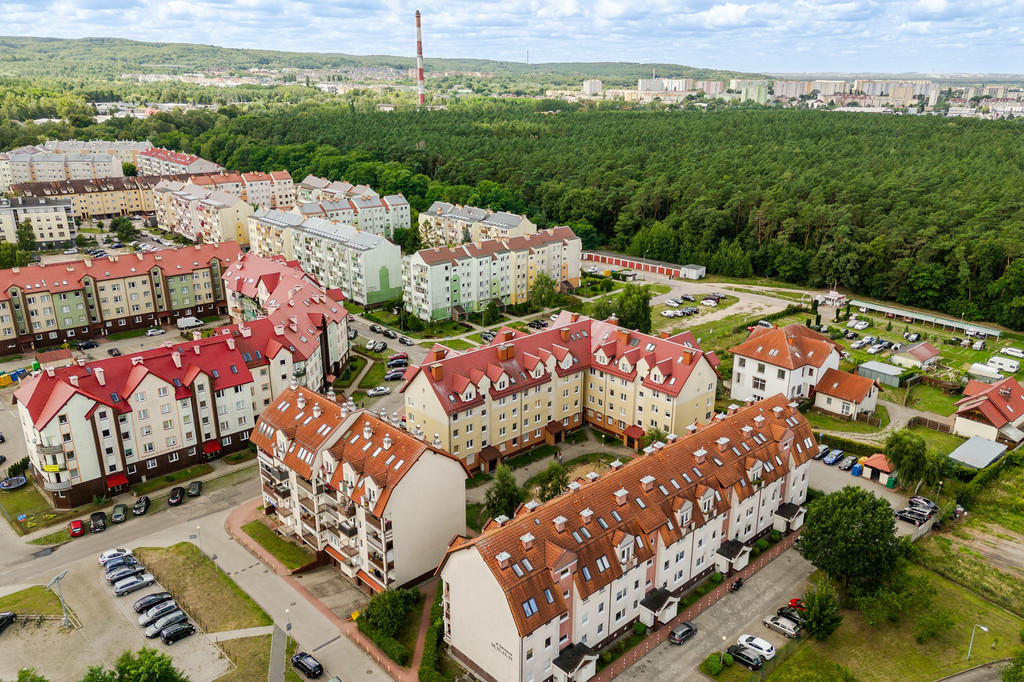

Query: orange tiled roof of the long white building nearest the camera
[[438, 394, 816, 636]]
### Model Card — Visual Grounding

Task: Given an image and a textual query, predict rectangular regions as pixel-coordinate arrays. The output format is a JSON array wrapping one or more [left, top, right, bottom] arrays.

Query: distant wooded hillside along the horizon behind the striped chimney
[[0, 36, 750, 80]]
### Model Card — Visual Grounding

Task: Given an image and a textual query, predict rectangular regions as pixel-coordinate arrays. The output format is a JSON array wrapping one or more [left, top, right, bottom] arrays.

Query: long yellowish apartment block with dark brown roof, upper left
[[10, 175, 188, 220]]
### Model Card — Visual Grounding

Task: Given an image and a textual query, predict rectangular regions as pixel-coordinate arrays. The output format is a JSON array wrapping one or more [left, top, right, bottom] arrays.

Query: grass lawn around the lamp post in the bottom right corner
[[771, 566, 1024, 682]]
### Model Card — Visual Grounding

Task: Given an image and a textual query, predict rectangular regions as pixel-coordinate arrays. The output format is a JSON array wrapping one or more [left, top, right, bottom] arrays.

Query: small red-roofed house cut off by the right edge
[[953, 377, 1024, 445]]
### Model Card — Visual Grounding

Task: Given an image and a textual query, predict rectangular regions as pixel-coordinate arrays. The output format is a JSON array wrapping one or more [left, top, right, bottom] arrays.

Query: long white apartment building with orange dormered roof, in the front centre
[[438, 395, 816, 682]]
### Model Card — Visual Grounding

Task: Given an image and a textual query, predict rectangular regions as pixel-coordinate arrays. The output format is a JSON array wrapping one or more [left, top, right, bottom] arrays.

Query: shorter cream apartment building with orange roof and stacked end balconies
[[252, 386, 469, 592]]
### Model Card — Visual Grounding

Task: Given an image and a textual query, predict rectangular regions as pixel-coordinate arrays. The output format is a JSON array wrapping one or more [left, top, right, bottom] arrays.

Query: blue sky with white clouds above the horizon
[[0, 0, 1024, 73]]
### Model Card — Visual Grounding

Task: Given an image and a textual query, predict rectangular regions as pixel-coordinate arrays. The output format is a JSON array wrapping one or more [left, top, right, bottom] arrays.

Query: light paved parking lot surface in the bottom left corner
[[0, 557, 231, 682]]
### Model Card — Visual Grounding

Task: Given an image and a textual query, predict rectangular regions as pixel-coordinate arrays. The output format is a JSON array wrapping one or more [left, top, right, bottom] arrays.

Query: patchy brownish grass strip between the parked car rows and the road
[[135, 543, 273, 632]]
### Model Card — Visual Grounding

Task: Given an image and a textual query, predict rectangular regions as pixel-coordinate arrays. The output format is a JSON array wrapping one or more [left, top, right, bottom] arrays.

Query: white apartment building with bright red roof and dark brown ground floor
[[14, 336, 258, 508]]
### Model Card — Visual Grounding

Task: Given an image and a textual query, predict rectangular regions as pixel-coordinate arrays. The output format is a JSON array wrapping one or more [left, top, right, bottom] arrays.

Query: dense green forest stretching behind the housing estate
[[6, 98, 1024, 330]]
